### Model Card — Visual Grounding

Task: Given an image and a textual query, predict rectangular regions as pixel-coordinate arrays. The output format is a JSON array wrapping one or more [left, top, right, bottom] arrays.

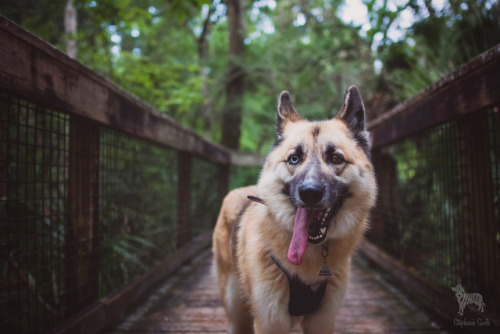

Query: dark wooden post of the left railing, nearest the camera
[[65, 116, 99, 316]]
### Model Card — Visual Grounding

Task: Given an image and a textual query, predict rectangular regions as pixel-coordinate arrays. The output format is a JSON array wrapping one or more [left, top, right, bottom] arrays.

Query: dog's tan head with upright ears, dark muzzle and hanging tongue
[[259, 86, 376, 264]]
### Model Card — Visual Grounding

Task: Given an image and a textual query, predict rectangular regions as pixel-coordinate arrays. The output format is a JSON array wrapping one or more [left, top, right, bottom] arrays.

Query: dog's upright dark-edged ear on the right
[[335, 86, 371, 157]]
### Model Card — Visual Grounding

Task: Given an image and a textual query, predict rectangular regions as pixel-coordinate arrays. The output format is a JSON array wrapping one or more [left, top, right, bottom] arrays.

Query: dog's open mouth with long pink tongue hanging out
[[288, 208, 334, 265]]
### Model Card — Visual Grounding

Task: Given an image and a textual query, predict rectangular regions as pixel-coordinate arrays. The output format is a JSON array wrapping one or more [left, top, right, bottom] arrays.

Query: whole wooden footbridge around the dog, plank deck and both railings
[[0, 16, 500, 333]]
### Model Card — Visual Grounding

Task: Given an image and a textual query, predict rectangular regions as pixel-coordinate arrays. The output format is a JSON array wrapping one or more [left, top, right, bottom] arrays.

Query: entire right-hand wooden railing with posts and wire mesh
[[365, 45, 500, 330]]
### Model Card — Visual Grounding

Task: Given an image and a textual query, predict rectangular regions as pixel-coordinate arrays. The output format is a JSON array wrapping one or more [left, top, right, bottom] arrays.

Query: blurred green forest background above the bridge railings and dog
[[0, 0, 500, 153]]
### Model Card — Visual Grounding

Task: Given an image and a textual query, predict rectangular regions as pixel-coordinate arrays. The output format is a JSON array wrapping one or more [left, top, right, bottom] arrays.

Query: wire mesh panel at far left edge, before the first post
[[0, 94, 69, 333]]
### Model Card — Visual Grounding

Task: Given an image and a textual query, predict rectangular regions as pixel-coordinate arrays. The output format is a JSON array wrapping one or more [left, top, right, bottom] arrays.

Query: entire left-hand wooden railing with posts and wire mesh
[[0, 16, 261, 333]]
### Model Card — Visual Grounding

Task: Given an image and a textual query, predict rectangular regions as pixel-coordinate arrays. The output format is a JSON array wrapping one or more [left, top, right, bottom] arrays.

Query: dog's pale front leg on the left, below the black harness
[[252, 282, 293, 334]]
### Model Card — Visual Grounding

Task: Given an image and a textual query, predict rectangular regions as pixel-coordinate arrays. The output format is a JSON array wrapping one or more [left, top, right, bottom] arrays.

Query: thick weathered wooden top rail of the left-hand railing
[[0, 15, 230, 163]]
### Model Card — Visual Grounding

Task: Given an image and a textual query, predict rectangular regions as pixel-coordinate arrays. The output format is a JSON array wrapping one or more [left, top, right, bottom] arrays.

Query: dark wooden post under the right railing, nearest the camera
[[457, 110, 499, 304]]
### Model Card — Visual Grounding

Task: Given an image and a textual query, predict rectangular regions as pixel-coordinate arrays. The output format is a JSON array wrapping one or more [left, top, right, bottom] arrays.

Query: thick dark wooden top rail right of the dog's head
[[369, 45, 500, 148]]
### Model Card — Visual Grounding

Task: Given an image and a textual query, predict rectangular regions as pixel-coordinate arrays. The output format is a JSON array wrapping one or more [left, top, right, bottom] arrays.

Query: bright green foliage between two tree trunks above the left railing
[[74, 0, 207, 127]]
